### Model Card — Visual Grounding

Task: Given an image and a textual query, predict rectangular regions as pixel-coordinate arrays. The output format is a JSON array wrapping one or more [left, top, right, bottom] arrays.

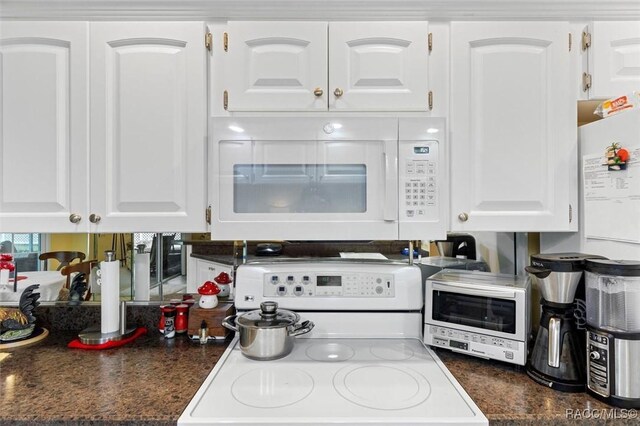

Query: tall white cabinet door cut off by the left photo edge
[[0, 22, 88, 232]]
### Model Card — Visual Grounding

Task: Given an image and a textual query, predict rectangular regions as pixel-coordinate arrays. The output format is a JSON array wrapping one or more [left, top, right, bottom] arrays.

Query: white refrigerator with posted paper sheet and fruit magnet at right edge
[[540, 109, 640, 260]]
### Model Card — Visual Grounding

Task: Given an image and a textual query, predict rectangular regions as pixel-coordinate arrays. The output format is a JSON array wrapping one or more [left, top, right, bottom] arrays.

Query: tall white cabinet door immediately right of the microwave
[[451, 22, 577, 232]]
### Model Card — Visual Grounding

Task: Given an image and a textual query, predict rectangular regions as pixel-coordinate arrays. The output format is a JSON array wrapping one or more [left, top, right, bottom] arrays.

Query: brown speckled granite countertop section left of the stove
[[0, 331, 227, 425]]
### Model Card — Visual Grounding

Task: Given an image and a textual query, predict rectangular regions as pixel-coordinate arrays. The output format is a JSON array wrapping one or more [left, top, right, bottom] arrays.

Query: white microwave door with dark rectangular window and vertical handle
[[212, 139, 397, 240]]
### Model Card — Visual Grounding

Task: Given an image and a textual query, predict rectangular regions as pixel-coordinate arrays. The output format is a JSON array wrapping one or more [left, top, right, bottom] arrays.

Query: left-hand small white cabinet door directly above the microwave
[[224, 21, 327, 111]]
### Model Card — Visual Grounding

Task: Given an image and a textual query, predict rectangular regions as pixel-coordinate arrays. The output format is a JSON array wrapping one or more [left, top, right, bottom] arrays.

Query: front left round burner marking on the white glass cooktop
[[231, 367, 313, 408]]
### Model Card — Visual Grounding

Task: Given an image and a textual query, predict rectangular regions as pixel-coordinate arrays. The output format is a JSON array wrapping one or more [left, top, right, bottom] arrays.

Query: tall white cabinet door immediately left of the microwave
[[90, 22, 207, 232]]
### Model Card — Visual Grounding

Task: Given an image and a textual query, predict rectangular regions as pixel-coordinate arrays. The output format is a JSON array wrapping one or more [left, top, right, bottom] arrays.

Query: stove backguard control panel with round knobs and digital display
[[263, 272, 395, 298]]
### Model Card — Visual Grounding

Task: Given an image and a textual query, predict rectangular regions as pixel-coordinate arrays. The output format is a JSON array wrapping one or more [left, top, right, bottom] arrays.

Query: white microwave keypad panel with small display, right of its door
[[398, 140, 440, 222]]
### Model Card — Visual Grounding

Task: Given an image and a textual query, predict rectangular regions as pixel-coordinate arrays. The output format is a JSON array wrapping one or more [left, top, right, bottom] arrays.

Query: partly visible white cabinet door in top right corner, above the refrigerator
[[589, 21, 640, 99]]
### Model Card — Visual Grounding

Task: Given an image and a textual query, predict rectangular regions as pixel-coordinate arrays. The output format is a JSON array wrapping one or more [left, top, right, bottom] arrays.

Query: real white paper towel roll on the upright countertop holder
[[100, 260, 120, 333]]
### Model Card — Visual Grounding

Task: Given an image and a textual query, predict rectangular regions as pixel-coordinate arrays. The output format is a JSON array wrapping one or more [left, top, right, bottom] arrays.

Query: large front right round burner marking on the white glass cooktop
[[333, 365, 431, 410]]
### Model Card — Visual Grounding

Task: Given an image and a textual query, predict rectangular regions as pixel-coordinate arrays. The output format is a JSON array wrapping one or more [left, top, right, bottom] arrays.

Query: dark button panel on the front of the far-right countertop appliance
[[587, 330, 612, 397]]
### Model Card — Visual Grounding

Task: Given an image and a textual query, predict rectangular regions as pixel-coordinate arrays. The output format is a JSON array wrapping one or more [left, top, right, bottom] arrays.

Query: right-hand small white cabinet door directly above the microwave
[[329, 22, 429, 111]]
